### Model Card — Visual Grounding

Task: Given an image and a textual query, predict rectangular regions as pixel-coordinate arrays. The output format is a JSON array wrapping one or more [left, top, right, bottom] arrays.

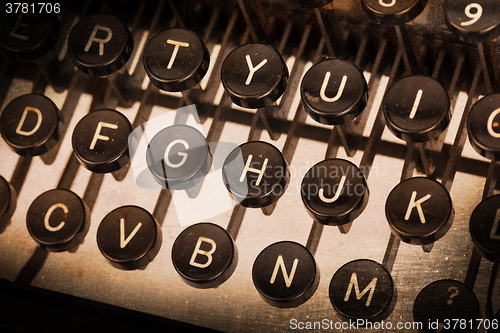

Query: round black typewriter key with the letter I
[[383, 75, 451, 142]]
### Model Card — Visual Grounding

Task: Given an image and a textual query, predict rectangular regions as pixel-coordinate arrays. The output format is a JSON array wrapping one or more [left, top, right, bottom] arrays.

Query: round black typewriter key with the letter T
[[143, 28, 210, 91]]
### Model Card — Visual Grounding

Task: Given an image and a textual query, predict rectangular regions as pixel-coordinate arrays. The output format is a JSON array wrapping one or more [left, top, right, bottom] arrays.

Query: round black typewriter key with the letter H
[[222, 141, 290, 208]]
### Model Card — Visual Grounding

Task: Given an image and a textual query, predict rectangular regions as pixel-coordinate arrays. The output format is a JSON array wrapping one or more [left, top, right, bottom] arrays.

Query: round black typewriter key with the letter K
[[385, 177, 455, 245]]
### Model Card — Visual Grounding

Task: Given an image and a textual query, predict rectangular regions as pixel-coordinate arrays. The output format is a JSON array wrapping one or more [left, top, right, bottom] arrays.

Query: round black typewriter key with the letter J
[[301, 159, 369, 225]]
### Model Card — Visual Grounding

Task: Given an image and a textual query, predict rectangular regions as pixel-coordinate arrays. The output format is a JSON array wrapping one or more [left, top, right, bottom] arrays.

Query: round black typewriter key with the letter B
[[172, 223, 238, 288]]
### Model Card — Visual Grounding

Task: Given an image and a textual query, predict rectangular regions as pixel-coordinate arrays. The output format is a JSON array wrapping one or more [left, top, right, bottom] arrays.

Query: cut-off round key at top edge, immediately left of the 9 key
[[361, 0, 427, 25]]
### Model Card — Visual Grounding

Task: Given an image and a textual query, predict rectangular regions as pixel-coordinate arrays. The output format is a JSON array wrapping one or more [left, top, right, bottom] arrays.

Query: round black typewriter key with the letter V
[[97, 206, 161, 269]]
